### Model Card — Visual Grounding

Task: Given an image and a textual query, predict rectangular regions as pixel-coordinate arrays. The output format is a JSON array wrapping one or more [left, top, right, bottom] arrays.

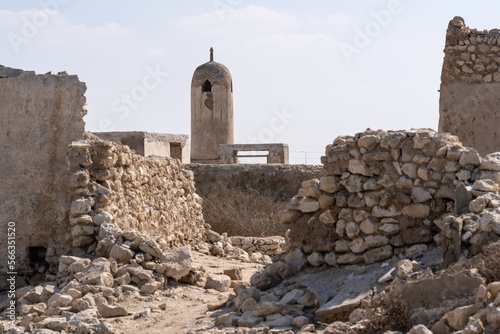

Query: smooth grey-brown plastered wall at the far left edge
[[0, 66, 86, 274]]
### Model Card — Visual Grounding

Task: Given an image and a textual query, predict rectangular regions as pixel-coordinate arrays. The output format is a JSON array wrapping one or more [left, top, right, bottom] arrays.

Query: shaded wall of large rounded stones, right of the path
[[277, 129, 494, 265]]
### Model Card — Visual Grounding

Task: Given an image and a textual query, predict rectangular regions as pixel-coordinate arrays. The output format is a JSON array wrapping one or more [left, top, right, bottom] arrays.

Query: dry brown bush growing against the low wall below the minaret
[[203, 188, 288, 237]]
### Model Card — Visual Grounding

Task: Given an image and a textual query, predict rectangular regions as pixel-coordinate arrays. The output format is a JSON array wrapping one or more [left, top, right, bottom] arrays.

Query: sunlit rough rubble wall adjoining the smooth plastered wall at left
[[69, 135, 206, 254]]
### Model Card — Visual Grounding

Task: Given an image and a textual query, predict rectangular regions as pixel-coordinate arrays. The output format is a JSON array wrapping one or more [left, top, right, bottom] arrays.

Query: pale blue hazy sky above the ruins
[[0, 0, 500, 164]]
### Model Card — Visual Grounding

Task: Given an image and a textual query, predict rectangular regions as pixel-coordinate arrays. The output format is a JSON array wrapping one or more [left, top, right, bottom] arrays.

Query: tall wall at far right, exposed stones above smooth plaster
[[439, 17, 500, 155]]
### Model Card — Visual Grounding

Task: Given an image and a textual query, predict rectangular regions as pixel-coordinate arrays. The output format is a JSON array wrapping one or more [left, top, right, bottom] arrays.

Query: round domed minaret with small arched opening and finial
[[191, 48, 234, 162]]
